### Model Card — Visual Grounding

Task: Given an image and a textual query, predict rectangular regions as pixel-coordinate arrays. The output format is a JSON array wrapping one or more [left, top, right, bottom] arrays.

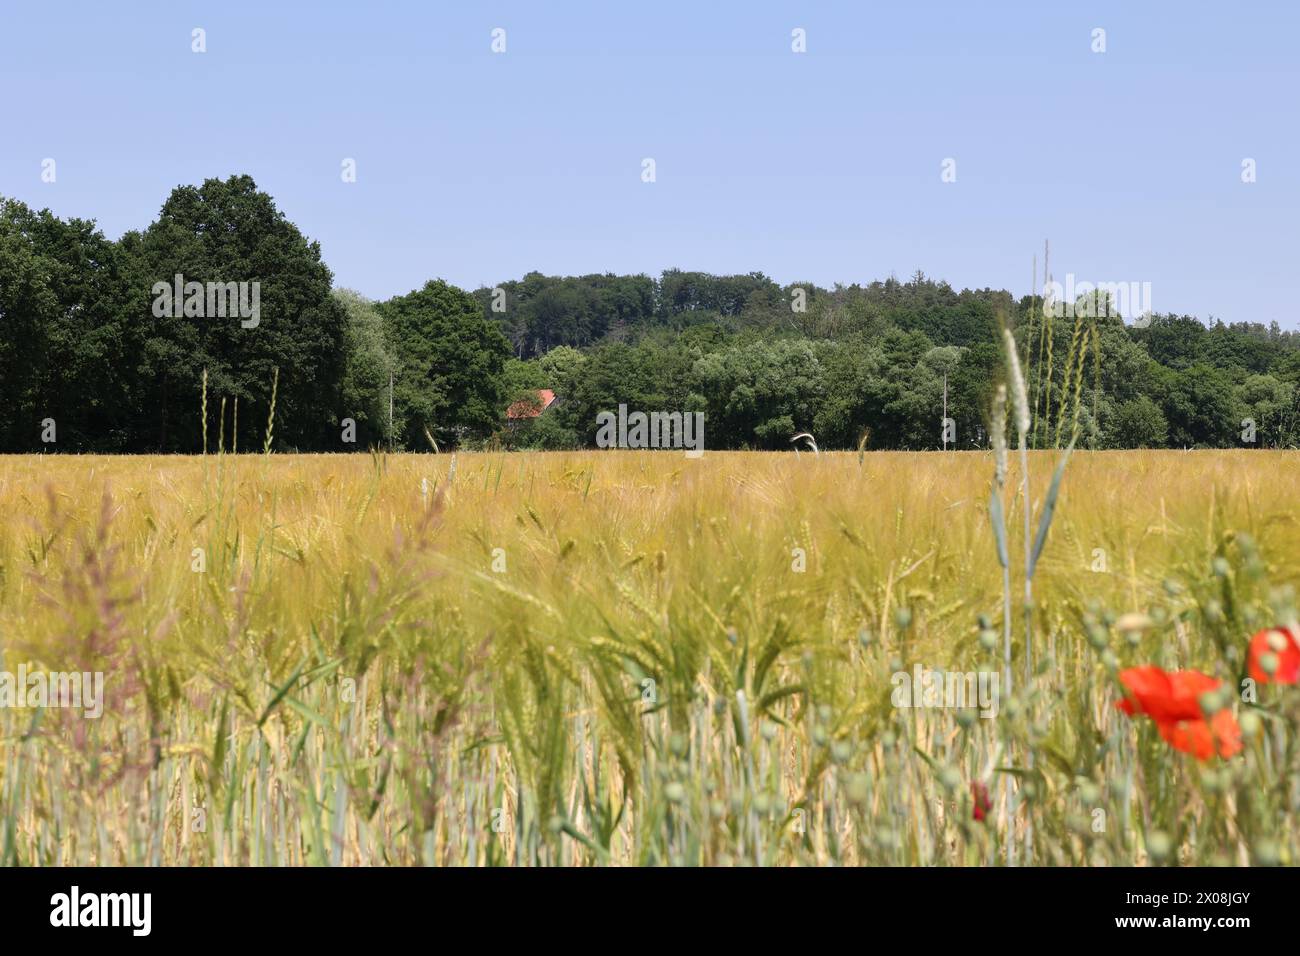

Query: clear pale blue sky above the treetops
[[0, 0, 1300, 328]]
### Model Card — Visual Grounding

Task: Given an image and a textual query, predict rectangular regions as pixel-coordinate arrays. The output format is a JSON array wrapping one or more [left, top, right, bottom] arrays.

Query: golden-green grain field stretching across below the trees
[[0, 450, 1300, 866]]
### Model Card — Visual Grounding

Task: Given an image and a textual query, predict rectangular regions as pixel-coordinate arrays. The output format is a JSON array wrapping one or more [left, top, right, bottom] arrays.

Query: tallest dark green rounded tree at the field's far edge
[[129, 176, 347, 451]]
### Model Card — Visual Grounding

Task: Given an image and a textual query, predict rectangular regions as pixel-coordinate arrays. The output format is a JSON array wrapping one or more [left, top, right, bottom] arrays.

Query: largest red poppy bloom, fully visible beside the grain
[[1115, 665, 1242, 760]]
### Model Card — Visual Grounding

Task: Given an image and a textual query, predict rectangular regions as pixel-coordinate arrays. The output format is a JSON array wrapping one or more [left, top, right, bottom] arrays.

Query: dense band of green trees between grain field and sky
[[0, 176, 1300, 453]]
